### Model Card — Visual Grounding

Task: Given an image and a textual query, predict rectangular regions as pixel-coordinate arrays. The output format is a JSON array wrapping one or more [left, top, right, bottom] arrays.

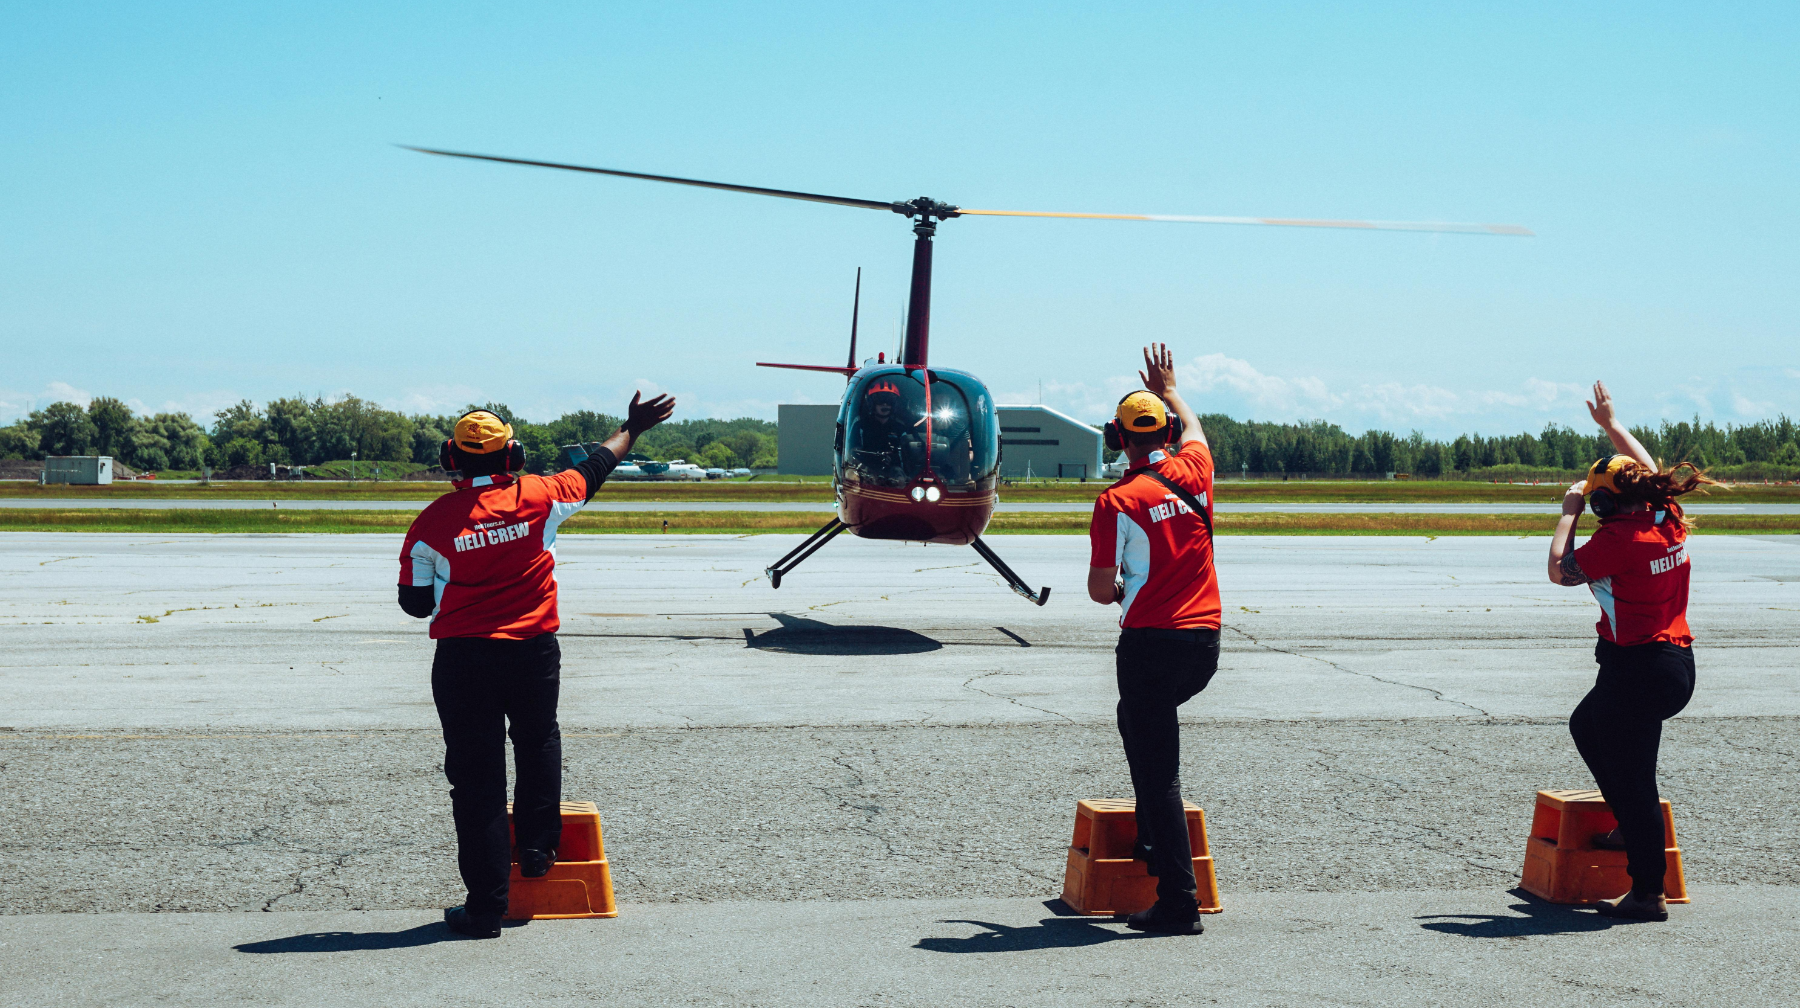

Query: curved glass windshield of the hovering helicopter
[[844, 369, 999, 490]]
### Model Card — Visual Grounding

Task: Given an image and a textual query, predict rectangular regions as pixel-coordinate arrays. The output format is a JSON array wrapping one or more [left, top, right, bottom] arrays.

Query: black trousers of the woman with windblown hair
[[1570, 637, 1694, 895]]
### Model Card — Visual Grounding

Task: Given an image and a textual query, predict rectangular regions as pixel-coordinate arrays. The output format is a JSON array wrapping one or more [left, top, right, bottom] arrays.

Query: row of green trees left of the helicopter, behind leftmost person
[[0, 396, 776, 472]]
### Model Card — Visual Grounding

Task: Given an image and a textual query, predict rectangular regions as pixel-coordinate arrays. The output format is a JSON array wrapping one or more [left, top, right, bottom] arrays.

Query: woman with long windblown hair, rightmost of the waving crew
[[1548, 382, 1714, 920]]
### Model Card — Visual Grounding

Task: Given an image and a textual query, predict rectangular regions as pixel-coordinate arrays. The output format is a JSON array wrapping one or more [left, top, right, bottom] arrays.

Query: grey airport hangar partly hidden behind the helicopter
[[776, 403, 1103, 479]]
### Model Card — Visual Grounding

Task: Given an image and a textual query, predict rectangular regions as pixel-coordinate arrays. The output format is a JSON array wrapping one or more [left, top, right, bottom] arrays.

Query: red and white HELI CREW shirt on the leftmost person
[[400, 470, 587, 641]]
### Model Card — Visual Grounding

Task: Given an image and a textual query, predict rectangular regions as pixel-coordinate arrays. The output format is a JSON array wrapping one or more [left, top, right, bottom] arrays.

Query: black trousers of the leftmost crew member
[[432, 634, 562, 914]]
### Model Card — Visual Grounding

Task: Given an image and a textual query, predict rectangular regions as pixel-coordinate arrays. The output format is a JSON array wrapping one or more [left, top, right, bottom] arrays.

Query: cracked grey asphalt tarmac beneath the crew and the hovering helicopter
[[0, 533, 1800, 1004]]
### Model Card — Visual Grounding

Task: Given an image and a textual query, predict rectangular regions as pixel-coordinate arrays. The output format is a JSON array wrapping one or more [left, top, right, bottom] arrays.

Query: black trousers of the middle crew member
[[1114, 630, 1219, 909]]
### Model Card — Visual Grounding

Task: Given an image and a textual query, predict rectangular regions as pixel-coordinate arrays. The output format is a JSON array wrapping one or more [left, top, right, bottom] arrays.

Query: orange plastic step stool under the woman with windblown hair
[[1519, 790, 1690, 904]]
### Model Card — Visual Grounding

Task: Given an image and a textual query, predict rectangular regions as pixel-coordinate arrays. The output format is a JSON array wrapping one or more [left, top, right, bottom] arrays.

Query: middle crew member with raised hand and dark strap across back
[[1087, 344, 1219, 934]]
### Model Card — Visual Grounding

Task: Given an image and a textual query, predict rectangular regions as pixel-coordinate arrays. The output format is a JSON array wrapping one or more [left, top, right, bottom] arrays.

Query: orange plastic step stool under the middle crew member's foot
[[1062, 797, 1224, 916]]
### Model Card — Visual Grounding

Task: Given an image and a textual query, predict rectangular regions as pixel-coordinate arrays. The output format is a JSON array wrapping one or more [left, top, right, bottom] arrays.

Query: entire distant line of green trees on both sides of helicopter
[[0, 396, 1800, 479]]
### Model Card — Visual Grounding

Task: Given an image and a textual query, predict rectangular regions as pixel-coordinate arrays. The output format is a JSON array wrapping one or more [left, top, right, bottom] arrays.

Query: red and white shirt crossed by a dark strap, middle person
[[1087, 441, 1219, 630]]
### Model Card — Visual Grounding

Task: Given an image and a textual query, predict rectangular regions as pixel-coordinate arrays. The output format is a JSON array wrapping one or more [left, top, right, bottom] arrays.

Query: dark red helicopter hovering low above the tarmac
[[407, 148, 1532, 605]]
